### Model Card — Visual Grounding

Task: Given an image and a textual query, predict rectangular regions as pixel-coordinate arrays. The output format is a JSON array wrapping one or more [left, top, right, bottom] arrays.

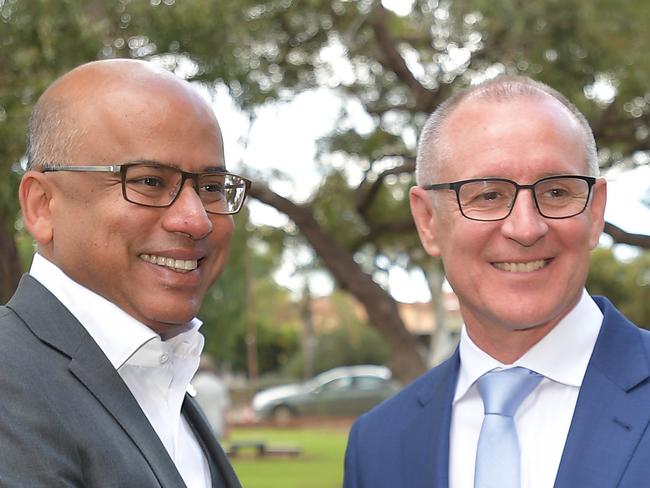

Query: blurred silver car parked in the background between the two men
[[253, 365, 400, 423]]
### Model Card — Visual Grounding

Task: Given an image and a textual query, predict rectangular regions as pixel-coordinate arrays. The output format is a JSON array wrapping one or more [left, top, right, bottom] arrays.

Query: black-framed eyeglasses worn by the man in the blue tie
[[422, 175, 596, 222]]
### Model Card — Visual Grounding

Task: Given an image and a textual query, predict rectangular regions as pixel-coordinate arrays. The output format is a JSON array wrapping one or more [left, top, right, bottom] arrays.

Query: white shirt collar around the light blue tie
[[454, 290, 603, 403]]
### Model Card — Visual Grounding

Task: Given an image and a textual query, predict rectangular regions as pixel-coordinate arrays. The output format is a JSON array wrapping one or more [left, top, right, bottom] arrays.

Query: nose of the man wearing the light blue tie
[[501, 190, 548, 247]]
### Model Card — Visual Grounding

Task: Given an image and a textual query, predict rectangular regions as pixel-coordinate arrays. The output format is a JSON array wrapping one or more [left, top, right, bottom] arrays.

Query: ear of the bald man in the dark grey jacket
[[18, 171, 54, 246]]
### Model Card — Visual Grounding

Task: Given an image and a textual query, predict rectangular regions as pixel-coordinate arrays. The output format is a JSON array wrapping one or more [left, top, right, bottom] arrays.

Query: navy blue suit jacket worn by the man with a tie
[[344, 297, 650, 488]]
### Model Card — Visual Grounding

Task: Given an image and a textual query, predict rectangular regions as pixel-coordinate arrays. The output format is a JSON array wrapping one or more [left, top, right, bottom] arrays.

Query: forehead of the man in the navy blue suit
[[440, 96, 587, 182]]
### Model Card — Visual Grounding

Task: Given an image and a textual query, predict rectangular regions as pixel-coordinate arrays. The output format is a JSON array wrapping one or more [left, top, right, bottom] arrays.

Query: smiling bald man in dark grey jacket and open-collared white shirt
[[0, 60, 250, 488]]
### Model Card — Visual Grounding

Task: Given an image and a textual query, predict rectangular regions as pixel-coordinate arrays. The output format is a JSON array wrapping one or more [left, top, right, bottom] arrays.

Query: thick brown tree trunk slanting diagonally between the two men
[[251, 183, 427, 382]]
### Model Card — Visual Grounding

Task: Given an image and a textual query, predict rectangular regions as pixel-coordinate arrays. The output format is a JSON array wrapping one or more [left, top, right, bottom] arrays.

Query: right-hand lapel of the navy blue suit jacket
[[555, 298, 650, 488]]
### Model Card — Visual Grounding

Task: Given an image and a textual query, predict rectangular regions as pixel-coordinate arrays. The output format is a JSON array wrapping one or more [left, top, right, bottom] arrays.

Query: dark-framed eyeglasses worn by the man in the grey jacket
[[41, 162, 251, 215]]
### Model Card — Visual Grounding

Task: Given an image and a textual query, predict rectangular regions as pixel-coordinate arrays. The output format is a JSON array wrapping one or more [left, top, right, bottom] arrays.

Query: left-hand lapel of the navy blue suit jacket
[[400, 349, 460, 488]]
